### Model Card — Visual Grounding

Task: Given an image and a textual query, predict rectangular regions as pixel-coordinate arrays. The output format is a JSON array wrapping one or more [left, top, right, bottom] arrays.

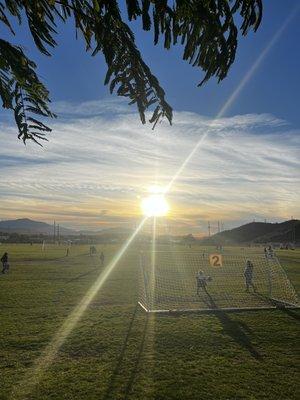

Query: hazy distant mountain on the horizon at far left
[[0, 218, 78, 235]]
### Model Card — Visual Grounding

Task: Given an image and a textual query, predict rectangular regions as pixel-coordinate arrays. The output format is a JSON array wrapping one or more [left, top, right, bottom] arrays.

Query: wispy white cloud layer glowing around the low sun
[[0, 101, 300, 233]]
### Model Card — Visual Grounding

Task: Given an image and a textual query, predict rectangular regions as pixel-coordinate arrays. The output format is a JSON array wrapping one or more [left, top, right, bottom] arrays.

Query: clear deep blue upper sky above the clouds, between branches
[[1, 0, 300, 126]]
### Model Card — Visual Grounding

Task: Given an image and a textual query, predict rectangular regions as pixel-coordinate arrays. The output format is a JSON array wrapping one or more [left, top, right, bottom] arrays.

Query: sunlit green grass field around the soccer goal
[[0, 245, 300, 400]]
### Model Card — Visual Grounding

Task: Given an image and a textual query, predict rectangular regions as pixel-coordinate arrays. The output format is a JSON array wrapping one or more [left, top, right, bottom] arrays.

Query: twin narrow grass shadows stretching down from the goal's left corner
[[103, 304, 148, 400]]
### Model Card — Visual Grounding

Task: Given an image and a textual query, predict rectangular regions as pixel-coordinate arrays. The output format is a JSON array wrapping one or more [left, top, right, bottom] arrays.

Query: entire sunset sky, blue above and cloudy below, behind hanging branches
[[0, 0, 300, 235]]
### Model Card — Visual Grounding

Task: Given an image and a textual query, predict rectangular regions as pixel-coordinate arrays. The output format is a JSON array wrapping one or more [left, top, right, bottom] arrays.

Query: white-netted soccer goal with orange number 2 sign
[[139, 251, 299, 312]]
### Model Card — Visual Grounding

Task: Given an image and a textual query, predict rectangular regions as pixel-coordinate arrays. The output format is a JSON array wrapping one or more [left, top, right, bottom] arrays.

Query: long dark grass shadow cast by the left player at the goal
[[206, 292, 263, 360]]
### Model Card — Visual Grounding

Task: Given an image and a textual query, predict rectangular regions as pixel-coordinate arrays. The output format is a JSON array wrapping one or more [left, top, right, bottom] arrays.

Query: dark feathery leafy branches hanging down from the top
[[0, 0, 262, 143]]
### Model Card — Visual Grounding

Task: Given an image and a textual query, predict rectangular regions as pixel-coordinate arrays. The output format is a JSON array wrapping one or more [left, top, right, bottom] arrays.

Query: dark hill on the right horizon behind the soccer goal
[[202, 219, 300, 244]]
